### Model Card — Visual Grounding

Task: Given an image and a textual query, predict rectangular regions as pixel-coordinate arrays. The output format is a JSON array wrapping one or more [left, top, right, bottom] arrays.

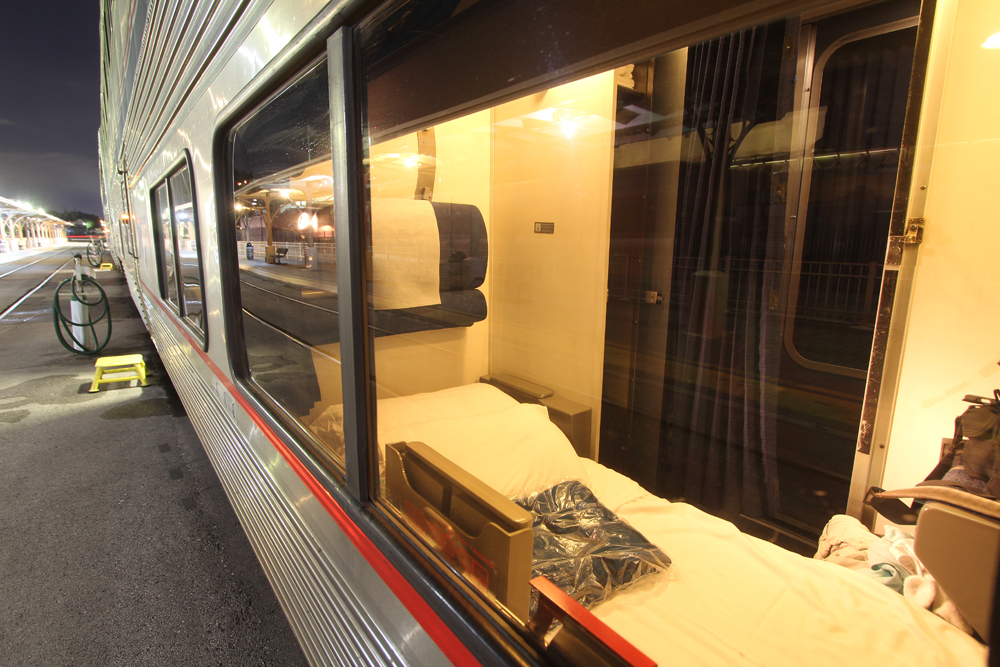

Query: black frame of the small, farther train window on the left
[[149, 148, 208, 351]]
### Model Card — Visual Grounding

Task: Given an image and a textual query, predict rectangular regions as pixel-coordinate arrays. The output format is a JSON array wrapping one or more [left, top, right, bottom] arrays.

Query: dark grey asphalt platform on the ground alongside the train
[[0, 253, 306, 667]]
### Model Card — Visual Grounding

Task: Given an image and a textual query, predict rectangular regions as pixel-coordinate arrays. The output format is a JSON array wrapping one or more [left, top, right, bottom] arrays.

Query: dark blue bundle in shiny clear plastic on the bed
[[516, 481, 670, 613]]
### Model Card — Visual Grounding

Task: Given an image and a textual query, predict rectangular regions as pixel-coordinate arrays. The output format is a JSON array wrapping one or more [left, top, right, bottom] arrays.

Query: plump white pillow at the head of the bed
[[378, 403, 590, 498]]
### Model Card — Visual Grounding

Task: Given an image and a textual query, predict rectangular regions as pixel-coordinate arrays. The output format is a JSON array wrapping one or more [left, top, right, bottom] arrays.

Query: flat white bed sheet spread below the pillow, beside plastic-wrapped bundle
[[584, 460, 987, 667]]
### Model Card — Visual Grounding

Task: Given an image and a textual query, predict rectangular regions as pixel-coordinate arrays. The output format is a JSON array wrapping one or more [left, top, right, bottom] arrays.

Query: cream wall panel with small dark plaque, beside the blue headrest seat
[[490, 72, 615, 448]]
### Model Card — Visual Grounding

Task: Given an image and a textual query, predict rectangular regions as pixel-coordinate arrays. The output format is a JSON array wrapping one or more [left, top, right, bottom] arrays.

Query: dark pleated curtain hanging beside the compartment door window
[[657, 24, 794, 516]]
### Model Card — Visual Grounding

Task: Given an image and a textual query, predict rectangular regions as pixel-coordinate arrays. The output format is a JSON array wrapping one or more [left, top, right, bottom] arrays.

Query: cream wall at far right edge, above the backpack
[[882, 1, 1000, 488]]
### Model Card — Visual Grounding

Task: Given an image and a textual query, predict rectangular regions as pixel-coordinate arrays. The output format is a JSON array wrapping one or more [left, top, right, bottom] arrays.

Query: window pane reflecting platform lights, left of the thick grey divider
[[224, 62, 344, 468]]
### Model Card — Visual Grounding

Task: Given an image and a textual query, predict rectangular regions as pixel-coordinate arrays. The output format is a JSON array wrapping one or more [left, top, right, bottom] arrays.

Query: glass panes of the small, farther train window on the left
[[151, 159, 205, 337]]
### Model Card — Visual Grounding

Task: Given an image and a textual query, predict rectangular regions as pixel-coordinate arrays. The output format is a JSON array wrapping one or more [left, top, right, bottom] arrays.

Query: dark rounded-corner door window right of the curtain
[[788, 28, 916, 370]]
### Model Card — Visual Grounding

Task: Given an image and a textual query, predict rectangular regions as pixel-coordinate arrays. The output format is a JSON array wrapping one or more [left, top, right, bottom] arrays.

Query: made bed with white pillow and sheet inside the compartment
[[312, 384, 987, 667]]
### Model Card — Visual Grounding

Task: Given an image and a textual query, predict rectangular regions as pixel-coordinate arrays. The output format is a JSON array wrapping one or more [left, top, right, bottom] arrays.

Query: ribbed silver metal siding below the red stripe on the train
[[151, 296, 445, 666]]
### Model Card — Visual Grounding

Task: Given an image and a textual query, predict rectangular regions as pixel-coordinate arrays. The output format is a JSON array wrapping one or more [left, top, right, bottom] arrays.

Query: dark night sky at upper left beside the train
[[0, 0, 103, 215]]
